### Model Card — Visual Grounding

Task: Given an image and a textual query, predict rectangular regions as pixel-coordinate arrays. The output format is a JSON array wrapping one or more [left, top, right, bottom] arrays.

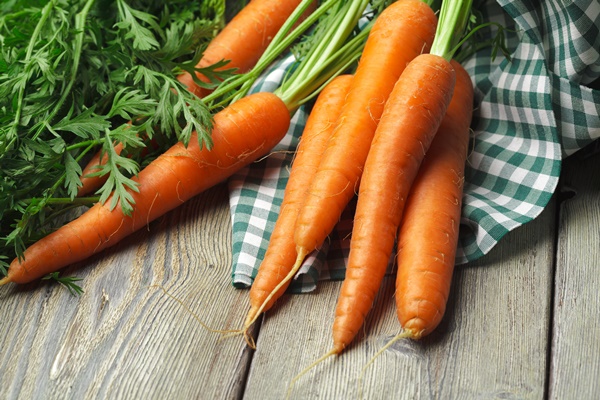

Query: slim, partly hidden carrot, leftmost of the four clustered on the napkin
[[247, 75, 352, 322]]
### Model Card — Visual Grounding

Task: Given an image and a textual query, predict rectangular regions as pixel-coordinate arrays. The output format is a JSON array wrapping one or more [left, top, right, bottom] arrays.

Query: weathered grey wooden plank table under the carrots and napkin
[[0, 145, 600, 400]]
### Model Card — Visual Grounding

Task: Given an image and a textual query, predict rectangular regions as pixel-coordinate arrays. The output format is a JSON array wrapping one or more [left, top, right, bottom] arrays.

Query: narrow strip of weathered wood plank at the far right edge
[[549, 155, 600, 399]]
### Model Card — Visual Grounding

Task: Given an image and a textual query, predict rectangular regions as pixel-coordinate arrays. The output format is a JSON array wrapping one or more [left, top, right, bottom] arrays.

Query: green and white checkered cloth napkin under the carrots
[[229, 0, 600, 292]]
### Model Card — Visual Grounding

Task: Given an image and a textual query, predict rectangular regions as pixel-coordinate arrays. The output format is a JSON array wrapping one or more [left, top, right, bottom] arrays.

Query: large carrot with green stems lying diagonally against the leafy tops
[[0, 0, 376, 284]]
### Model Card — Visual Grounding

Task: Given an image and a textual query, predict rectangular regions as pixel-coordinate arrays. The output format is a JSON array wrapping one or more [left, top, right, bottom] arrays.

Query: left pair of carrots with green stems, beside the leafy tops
[[0, 0, 376, 285]]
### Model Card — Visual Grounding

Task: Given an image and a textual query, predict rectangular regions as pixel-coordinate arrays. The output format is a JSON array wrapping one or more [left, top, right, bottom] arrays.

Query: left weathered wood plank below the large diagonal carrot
[[0, 186, 251, 399]]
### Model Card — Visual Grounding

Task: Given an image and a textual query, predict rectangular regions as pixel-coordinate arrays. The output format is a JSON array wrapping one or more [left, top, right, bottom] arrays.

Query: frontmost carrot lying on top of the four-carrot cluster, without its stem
[[333, 54, 455, 354]]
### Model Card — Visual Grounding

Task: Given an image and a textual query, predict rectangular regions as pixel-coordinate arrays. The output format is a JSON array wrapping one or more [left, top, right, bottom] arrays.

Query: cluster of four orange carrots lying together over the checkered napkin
[[244, 0, 473, 378]]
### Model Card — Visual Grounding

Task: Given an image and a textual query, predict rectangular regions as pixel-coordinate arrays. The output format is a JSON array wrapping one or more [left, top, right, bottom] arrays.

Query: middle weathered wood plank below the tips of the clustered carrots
[[245, 203, 555, 399]]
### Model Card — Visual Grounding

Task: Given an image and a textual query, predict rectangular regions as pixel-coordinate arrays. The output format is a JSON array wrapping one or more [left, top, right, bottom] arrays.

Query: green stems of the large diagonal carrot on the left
[[204, 0, 370, 112]]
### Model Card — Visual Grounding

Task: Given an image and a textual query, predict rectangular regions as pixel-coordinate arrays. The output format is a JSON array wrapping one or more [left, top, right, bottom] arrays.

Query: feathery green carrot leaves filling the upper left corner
[[0, 0, 231, 285]]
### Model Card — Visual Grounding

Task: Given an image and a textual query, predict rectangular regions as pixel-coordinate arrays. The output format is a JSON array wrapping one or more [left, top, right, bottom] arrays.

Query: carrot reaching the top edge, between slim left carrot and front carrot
[[294, 0, 437, 253]]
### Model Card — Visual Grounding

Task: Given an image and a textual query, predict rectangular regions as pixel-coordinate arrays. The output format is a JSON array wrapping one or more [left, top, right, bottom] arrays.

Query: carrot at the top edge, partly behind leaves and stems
[[177, 0, 317, 97]]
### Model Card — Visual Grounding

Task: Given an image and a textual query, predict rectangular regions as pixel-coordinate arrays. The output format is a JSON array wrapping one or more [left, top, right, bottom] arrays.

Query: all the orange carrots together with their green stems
[[0, 0, 473, 368]]
